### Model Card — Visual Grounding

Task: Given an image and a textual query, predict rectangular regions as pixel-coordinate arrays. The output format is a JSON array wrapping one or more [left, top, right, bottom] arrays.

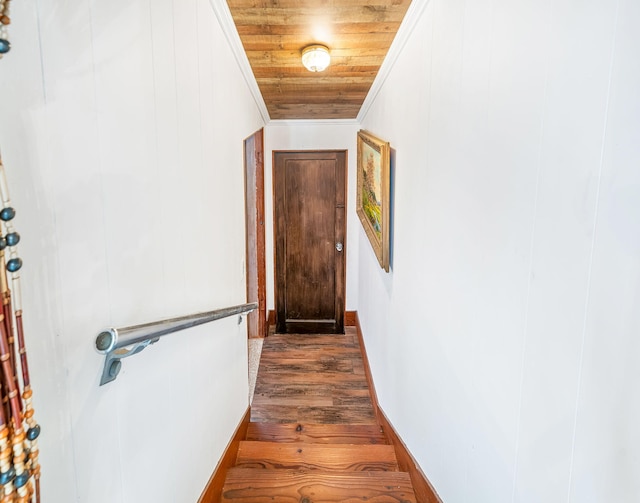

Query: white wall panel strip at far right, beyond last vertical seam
[[569, 1, 640, 502]]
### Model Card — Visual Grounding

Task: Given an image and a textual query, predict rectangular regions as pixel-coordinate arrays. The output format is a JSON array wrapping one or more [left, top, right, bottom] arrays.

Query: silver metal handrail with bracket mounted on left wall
[[96, 302, 258, 386]]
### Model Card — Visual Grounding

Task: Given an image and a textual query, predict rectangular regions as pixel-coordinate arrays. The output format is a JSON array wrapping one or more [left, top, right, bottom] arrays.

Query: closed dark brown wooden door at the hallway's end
[[273, 151, 346, 333]]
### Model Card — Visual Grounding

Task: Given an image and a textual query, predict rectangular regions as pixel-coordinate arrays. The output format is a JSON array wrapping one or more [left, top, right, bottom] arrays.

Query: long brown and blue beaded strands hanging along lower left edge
[[0, 159, 40, 503]]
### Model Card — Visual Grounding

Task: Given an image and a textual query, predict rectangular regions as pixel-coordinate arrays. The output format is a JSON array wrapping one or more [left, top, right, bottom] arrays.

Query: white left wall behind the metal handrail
[[0, 0, 263, 503]]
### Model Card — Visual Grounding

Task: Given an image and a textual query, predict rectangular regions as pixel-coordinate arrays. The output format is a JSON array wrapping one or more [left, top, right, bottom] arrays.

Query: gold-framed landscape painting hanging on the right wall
[[356, 130, 390, 272]]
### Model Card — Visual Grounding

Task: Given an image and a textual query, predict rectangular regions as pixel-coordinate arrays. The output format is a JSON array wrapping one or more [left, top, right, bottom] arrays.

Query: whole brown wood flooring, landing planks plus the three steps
[[220, 327, 417, 503]]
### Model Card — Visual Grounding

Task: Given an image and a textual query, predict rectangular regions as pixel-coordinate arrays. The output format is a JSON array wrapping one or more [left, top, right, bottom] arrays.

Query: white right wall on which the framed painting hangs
[[358, 0, 640, 503]]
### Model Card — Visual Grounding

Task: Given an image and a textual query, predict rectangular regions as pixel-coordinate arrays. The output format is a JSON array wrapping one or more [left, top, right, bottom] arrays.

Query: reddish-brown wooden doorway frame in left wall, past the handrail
[[244, 129, 268, 338]]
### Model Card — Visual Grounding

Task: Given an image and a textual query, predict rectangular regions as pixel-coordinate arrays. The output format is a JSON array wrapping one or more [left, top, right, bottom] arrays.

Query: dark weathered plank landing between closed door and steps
[[251, 327, 376, 424]]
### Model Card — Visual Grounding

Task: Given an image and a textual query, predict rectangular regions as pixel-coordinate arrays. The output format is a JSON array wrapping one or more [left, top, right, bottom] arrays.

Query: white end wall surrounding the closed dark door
[[264, 120, 360, 310]]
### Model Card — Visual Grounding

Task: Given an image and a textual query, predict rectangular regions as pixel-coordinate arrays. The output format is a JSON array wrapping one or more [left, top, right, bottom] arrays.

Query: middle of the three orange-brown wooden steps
[[236, 440, 398, 472]]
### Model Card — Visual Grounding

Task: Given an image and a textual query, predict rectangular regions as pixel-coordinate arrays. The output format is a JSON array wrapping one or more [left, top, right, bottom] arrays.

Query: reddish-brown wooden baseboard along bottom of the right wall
[[354, 311, 442, 503]]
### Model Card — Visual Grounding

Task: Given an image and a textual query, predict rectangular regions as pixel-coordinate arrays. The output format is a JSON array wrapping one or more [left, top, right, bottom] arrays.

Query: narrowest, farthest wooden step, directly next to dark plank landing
[[246, 423, 388, 444]]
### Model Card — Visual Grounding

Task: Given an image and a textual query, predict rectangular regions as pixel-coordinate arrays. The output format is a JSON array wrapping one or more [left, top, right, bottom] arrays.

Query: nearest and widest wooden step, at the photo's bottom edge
[[221, 468, 417, 503]]
